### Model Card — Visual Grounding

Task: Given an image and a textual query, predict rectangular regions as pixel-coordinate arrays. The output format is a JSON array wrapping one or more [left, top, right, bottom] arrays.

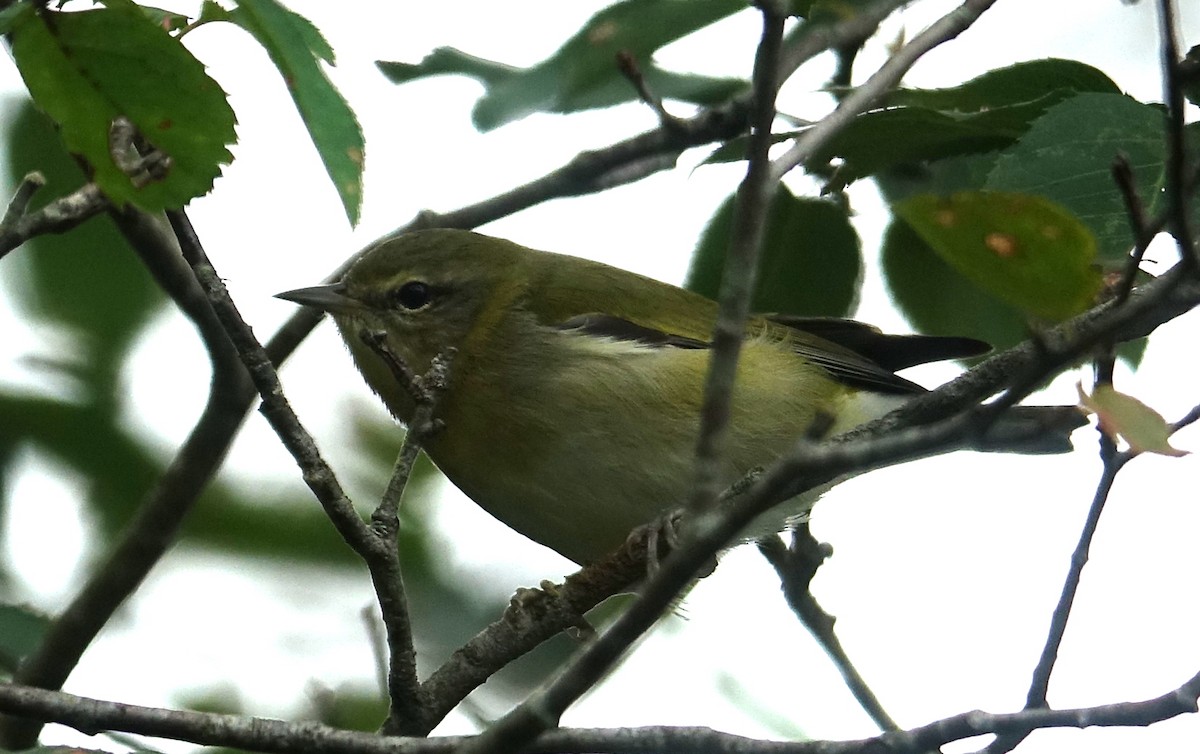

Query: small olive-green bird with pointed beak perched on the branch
[[278, 229, 1081, 563]]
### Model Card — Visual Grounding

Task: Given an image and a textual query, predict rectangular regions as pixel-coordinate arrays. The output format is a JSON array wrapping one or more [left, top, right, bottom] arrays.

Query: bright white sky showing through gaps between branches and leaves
[[0, 0, 1200, 753]]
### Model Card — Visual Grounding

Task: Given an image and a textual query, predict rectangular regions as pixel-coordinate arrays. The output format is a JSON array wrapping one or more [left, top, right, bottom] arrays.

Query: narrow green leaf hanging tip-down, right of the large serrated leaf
[[229, 0, 365, 226]]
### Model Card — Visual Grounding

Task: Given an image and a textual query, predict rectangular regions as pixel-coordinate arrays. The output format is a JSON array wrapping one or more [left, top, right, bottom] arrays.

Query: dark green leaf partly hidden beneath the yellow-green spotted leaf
[[881, 220, 1028, 349]]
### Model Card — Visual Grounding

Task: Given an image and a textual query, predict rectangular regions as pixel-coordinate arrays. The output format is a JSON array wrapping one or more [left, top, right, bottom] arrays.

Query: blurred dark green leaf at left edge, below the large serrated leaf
[[0, 100, 164, 398]]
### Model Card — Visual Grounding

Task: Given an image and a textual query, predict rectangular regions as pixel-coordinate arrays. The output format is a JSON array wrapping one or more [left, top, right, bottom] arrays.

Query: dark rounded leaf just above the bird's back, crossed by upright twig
[[684, 186, 863, 317]]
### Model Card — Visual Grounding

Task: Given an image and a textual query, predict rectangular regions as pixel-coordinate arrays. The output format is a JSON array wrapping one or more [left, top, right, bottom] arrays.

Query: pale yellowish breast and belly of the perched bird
[[430, 331, 902, 562]]
